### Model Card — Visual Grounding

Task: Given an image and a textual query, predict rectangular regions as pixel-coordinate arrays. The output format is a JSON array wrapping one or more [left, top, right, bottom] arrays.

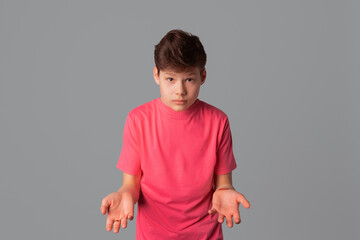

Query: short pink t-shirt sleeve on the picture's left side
[[116, 114, 141, 175]]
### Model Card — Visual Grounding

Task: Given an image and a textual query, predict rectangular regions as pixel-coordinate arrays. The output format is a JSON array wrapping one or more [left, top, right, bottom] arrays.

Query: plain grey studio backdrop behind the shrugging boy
[[0, 0, 360, 240]]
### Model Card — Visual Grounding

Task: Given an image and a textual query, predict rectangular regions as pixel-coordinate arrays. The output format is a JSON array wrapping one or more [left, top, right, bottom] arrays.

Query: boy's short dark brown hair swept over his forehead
[[154, 29, 206, 73]]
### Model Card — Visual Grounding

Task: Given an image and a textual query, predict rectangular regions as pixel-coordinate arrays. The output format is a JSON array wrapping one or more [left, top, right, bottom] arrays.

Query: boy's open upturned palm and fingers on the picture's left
[[100, 191, 135, 233]]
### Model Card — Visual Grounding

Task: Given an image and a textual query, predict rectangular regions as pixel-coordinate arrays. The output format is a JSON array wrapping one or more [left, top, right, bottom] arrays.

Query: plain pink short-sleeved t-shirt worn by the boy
[[116, 97, 236, 240]]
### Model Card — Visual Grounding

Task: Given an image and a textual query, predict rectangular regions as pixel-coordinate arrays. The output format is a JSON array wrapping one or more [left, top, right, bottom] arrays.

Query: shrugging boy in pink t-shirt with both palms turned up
[[100, 30, 250, 240]]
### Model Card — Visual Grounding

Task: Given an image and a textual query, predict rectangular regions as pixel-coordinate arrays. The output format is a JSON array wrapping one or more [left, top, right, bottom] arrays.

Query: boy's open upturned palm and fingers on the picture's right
[[209, 189, 250, 228]]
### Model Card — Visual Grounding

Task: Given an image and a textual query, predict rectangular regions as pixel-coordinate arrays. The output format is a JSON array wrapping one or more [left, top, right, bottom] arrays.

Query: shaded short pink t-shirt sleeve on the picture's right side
[[214, 117, 237, 175]]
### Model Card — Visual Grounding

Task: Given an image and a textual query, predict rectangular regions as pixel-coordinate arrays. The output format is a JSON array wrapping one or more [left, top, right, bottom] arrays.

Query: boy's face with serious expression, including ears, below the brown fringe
[[154, 66, 206, 111]]
